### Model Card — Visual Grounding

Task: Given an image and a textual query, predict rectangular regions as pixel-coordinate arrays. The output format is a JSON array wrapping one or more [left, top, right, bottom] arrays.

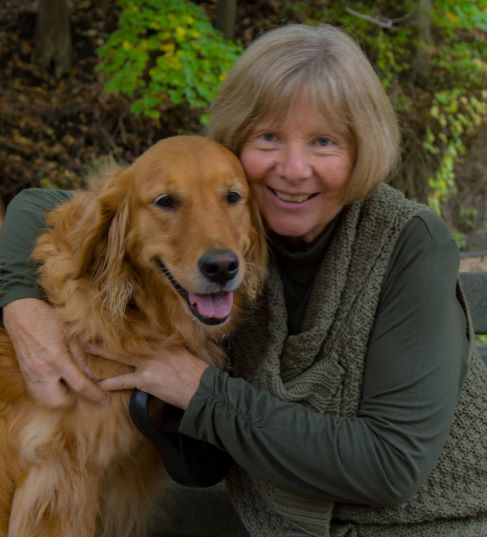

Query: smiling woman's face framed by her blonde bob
[[240, 98, 354, 244]]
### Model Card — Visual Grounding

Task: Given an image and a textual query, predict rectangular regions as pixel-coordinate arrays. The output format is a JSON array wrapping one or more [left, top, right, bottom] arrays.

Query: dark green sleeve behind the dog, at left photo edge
[[0, 188, 71, 308]]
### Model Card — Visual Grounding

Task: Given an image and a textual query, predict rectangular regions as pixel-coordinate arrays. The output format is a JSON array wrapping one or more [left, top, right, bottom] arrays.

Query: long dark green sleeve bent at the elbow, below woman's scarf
[[180, 212, 468, 506]]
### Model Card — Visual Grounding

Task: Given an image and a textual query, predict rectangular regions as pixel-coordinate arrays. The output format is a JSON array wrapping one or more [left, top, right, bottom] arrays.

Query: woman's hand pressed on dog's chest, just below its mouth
[[90, 345, 208, 409]]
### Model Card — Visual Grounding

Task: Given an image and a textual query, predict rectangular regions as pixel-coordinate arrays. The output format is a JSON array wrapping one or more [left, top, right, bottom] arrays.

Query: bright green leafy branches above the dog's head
[[98, 0, 242, 119]]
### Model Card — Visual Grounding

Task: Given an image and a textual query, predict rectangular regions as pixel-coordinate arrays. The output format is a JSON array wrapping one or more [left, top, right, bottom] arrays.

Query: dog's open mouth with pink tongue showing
[[158, 259, 233, 326]]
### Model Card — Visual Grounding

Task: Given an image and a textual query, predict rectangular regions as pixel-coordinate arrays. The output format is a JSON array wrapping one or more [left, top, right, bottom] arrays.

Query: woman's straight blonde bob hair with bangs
[[207, 24, 399, 202]]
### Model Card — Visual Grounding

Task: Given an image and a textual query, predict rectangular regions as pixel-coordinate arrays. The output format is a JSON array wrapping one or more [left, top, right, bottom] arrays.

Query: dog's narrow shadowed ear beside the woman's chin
[[244, 199, 267, 298]]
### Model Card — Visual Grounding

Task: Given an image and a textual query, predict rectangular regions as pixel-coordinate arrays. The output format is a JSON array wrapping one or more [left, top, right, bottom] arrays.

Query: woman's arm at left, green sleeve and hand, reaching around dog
[[0, 189, 106, 406]]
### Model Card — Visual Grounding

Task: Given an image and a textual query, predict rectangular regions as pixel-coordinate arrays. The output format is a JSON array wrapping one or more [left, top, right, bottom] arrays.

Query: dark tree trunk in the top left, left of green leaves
[[35, 0, 71, 76]]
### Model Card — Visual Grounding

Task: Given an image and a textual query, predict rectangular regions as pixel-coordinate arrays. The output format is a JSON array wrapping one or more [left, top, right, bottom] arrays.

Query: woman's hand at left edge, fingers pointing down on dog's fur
[[3, 298, 107, 407]]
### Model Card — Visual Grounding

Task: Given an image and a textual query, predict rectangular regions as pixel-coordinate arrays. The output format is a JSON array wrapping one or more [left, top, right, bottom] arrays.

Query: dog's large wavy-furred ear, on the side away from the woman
[[71, 167, 133, 317]]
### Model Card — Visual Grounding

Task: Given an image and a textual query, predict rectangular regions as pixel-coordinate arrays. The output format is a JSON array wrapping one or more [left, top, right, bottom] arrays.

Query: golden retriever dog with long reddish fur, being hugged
[[0, 136, 266, 537]]
